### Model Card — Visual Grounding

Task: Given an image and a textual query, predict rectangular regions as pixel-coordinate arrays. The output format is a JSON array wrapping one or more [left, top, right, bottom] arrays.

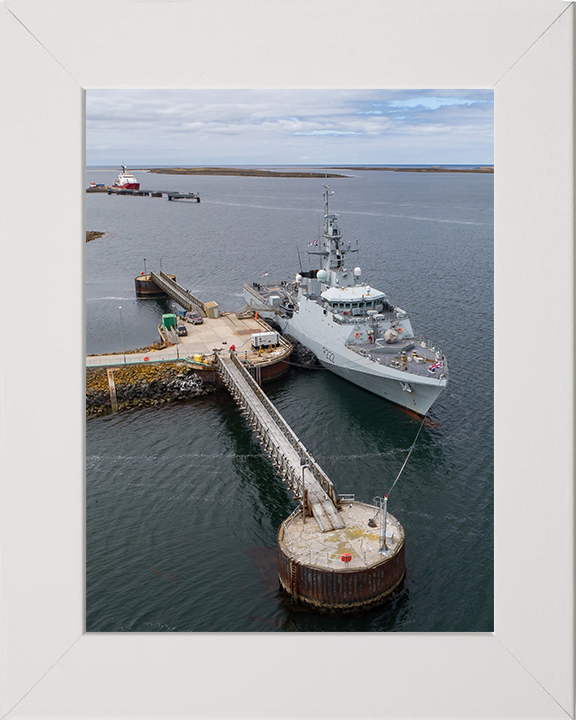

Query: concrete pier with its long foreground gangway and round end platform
[[86, 296, 405, 611]]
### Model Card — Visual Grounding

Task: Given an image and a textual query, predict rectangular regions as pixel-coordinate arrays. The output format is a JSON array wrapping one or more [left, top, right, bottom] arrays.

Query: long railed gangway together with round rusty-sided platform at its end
[[218, 353, 405, 611]]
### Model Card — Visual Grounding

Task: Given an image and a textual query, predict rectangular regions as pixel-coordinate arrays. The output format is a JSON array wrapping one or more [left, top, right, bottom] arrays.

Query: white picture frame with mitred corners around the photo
[[0, 0, 574, 718]]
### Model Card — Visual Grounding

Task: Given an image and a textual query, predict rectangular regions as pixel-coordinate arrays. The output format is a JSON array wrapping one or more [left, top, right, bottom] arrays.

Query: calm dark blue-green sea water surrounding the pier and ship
[[86, 171, 493, 632]]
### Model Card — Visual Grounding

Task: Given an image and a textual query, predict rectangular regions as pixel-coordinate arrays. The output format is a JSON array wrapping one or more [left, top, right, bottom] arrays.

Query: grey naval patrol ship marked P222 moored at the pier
[[244, 185, 448, 415]]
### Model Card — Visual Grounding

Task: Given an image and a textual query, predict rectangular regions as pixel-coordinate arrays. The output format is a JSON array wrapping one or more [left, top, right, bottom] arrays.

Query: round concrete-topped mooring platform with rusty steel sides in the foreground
[[278, 502, 406, 611]]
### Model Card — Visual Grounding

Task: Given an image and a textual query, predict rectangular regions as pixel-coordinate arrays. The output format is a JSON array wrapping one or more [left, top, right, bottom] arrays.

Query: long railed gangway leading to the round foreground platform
[[216, 352, 345, 532]]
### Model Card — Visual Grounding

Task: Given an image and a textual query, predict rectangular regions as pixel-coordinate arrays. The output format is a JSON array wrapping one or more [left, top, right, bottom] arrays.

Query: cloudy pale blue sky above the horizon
[[86, 90, 494, 168]]
